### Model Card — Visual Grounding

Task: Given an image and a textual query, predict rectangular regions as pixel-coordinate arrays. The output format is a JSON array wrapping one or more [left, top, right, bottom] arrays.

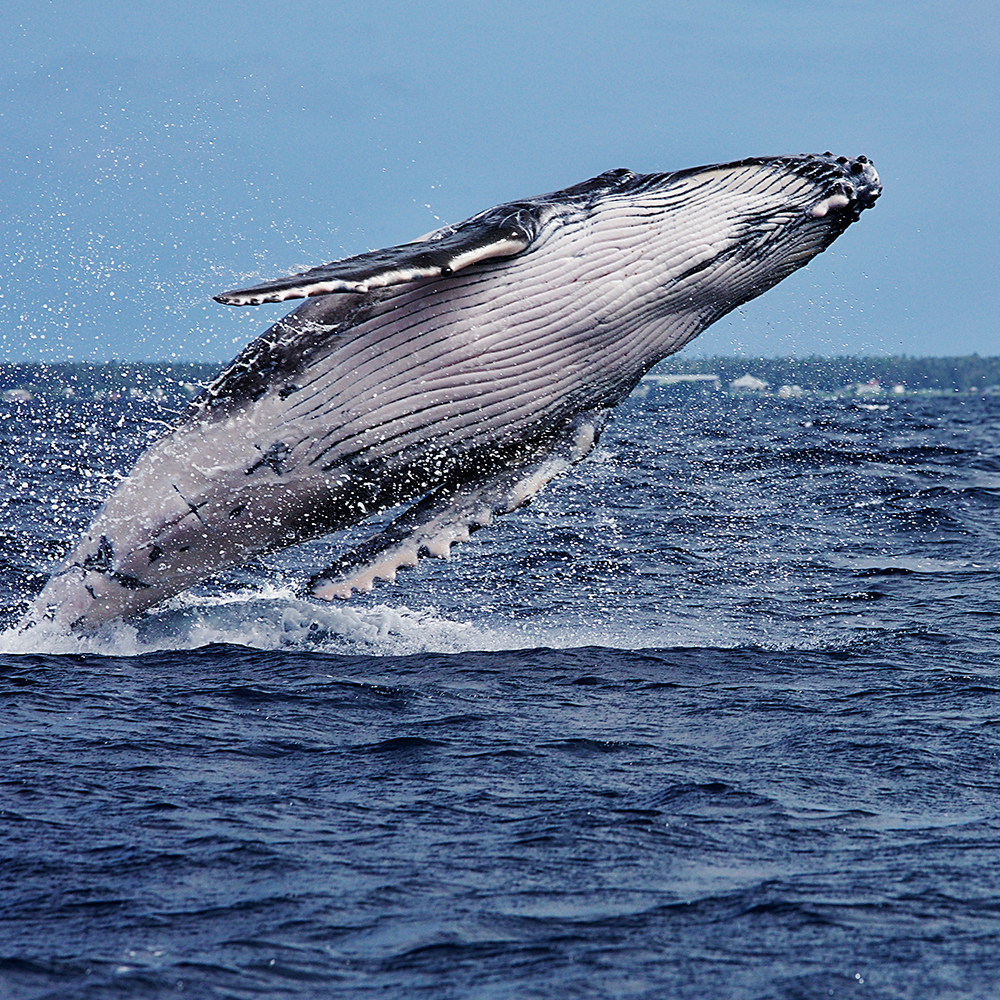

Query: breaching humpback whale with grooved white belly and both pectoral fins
[[33, 153, 881, 628]]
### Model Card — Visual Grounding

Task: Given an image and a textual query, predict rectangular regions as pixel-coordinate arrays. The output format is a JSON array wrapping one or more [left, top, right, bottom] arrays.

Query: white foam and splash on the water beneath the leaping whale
[[0, 556, 888, 657]]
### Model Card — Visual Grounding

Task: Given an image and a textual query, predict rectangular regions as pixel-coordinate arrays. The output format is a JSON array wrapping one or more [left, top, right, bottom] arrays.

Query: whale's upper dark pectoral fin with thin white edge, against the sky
[[215, 205, 538, 306]]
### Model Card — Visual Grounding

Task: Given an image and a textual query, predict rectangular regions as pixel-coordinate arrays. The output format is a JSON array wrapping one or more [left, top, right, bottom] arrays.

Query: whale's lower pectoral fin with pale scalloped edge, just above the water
[[309, 410, 609, 601]]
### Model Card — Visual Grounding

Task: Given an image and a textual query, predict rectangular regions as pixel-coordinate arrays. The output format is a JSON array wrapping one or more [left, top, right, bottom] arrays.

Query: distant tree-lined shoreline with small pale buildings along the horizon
[[0, 354, 1000, 402]]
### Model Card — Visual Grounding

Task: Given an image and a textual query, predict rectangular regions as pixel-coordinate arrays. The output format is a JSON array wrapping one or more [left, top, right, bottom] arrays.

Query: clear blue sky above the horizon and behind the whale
[[0, 0, 1000, 363]]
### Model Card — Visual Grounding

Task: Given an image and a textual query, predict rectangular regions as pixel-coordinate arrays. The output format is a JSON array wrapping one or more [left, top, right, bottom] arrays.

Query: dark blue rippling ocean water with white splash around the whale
[[0, 378, 1000, 1000]]
